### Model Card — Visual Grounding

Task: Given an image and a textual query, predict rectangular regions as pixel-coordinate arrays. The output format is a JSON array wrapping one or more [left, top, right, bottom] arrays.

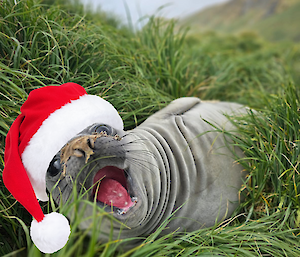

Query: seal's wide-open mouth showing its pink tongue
[[93, 166, 134, 212]]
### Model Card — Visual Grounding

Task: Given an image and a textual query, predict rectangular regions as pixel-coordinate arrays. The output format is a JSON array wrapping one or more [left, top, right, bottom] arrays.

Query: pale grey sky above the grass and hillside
[[81, 0, 228, 25]]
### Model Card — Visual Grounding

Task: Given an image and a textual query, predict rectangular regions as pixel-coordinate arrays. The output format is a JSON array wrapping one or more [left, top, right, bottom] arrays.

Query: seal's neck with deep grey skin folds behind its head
[[126, 128, 177, 234]]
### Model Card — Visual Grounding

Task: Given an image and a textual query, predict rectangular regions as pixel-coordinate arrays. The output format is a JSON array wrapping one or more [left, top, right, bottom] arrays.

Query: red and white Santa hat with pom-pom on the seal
[[3, 83, 123, 253]]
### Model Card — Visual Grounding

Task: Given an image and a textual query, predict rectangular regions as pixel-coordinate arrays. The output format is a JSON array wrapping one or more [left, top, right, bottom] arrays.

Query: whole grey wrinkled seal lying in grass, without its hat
[[46, 97, 246, 246]]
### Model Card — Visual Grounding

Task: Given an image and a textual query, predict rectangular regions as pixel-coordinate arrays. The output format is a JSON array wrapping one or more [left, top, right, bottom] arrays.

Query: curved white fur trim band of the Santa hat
[[22, 95, 123, 201]]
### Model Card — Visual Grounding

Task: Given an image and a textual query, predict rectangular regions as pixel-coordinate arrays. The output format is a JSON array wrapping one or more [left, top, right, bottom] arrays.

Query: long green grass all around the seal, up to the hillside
[[0, 0, 300, 256]]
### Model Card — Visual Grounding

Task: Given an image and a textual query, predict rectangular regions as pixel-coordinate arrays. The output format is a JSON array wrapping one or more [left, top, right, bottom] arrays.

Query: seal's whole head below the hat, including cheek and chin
[[46, 123, 153, 234]]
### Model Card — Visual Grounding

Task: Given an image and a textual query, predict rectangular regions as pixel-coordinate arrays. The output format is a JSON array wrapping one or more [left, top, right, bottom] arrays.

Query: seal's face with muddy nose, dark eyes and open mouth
[[47, 124, 137, 215]]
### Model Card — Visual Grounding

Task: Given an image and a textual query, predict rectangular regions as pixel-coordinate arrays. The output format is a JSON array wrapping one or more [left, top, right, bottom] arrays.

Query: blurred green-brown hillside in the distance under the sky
[[181, 0, 300, 42]]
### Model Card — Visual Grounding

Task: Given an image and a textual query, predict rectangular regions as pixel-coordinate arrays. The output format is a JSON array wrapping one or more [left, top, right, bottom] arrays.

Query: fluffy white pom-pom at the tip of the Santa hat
[[30, 212, 71, 253]]
